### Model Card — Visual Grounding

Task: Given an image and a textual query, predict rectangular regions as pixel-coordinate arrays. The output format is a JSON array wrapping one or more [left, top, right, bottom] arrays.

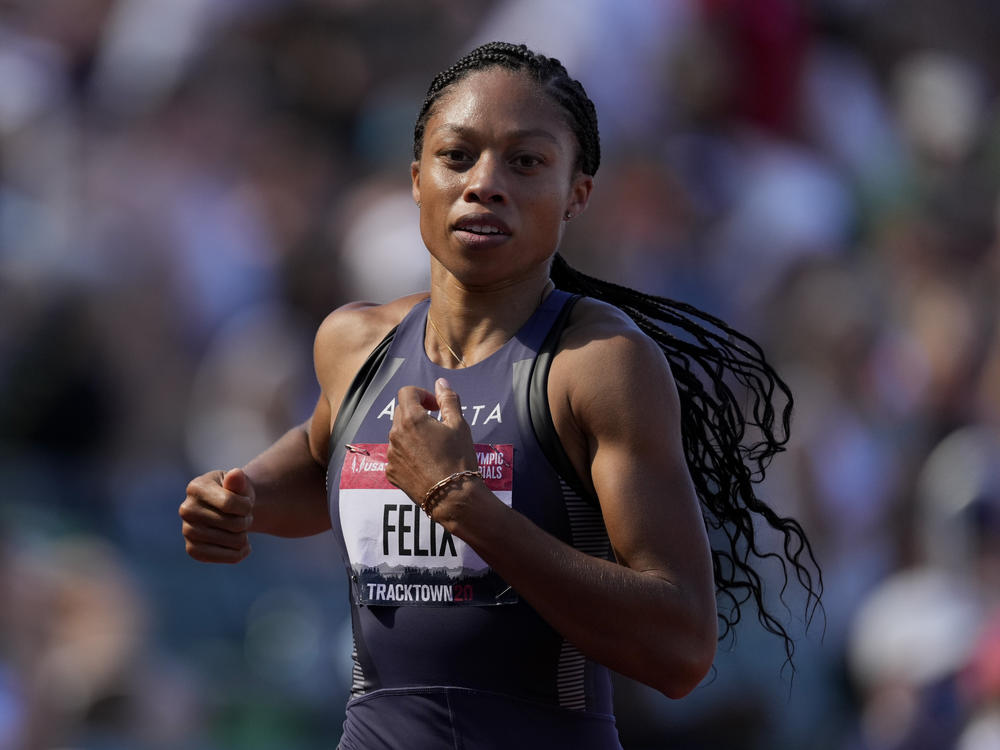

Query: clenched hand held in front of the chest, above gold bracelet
[[385, 378, 478, 505]]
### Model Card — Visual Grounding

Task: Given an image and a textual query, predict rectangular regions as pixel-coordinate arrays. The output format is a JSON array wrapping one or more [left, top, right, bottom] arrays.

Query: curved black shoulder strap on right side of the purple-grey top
[[527, 294, 600, 507]]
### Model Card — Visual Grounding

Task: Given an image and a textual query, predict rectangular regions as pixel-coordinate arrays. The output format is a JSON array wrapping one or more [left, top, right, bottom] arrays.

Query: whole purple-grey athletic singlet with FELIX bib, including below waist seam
[[327, 290, 620, 750]]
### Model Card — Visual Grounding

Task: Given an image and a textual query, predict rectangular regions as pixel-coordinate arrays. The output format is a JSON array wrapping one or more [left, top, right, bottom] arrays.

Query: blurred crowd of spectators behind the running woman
[[0, 0, 1000, 750]]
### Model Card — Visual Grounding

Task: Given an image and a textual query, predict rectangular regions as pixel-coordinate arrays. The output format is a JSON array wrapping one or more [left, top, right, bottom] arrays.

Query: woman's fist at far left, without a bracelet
[[178, 469, 255, 563]]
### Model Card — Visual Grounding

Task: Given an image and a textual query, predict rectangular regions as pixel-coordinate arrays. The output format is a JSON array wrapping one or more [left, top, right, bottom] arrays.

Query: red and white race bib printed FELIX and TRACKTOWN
[[340, 443, 517, 606]]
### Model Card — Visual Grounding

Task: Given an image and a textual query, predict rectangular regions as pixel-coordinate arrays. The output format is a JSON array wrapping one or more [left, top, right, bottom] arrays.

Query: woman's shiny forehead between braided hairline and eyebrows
[[427, 67, 574, 139]]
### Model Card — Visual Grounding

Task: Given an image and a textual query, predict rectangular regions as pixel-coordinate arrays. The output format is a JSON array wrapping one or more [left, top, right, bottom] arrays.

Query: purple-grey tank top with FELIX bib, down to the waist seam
[[327, 290, 613, 715]]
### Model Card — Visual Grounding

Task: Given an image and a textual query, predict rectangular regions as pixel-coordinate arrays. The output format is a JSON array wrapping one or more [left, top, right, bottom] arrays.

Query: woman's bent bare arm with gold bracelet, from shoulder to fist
[[387, 320, 716, 697]]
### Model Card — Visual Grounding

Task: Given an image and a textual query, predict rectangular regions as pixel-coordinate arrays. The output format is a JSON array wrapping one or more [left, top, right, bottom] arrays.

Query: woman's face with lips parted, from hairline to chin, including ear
[[412, 68, 593, 288]]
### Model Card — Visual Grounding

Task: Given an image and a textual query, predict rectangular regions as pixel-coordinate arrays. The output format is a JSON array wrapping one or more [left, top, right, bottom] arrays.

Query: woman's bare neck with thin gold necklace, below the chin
[[424, 266, 553, 368]]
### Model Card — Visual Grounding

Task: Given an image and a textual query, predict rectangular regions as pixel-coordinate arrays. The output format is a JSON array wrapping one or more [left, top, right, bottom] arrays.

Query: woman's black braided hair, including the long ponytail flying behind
[[413, 42, 823, 663]]
